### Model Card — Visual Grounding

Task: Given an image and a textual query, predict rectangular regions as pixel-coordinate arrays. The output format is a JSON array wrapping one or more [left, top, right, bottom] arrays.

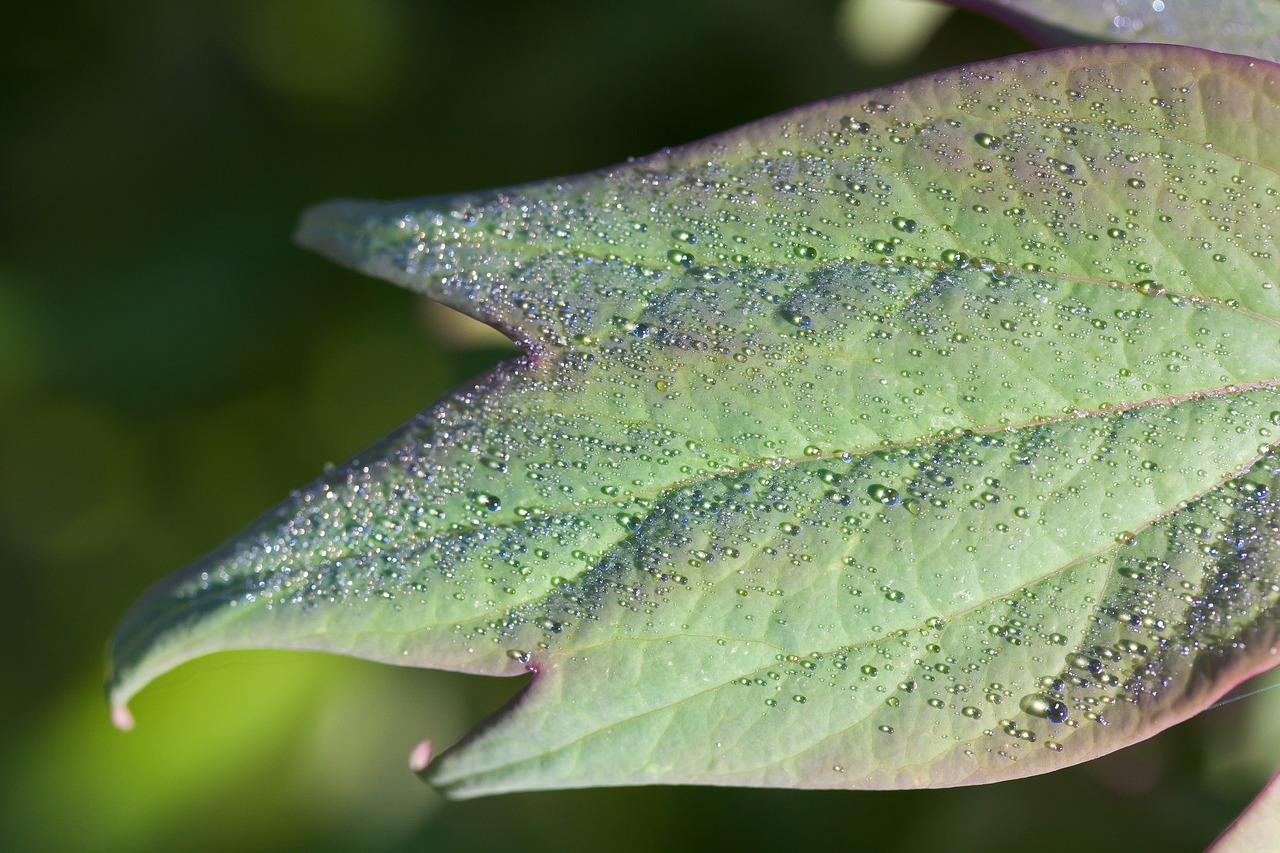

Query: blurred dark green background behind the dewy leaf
[[0, 0, 1280, 853]]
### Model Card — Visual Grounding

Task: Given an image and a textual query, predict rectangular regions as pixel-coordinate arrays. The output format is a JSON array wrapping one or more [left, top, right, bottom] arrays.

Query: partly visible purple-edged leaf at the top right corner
[[951, 0, 1280, 60]]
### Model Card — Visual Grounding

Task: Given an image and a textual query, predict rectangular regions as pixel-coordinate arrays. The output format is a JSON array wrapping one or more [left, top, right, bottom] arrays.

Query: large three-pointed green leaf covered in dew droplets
[[109, 46, 1280, 797]]
